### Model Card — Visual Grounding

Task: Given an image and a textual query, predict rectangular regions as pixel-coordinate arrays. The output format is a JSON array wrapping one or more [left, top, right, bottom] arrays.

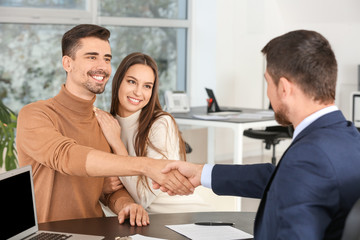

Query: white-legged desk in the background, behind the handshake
[[172, 107, 279, 164]]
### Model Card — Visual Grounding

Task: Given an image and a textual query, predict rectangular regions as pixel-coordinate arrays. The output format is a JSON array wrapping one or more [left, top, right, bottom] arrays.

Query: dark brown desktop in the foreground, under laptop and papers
[[39, 212, 255, 240]]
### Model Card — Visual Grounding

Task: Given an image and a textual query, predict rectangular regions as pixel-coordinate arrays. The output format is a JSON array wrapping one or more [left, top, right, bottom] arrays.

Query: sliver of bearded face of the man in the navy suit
[[265, 71, 291, 126]]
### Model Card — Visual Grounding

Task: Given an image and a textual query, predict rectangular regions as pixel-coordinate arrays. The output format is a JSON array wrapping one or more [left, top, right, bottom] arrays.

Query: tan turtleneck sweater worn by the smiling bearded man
[[16, 85, 110, 223]]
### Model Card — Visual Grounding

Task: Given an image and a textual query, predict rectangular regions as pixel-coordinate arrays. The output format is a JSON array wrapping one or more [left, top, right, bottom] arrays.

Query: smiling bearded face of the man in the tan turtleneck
[[67, 37, 111, 96]]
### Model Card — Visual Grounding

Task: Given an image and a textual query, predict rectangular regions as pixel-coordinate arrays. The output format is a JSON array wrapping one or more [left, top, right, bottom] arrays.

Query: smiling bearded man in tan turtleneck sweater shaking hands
[[16, 24, 193, 226]]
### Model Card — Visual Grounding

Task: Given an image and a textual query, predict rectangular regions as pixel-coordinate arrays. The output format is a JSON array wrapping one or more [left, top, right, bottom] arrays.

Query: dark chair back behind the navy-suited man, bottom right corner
[[341, 199, 360, 240]]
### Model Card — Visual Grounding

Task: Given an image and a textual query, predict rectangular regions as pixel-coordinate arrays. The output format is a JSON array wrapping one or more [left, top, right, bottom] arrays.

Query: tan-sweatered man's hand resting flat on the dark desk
[[118, 203, 150, 227]]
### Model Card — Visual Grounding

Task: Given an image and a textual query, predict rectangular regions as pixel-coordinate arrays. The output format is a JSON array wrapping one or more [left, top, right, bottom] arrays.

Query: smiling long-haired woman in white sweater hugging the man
[[96, 53, 211, 213]]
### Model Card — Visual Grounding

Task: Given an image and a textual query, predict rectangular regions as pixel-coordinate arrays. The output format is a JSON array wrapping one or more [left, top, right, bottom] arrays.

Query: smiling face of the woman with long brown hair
[[118, 64, 155, 117]]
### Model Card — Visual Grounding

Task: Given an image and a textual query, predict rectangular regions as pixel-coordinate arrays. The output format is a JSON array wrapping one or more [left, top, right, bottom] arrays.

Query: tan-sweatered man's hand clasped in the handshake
[[145, 159, 195, 195]]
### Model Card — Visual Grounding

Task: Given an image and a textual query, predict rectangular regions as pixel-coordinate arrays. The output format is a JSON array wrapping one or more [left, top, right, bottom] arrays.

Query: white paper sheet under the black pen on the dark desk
[[165, 224, 253, 240]]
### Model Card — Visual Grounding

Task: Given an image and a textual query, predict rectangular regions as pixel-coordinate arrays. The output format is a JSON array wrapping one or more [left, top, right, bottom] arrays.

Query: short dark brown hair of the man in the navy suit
[[261, 30, 337, 103]]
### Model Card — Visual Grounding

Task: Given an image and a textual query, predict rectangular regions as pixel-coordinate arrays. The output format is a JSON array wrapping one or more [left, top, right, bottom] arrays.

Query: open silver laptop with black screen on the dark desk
[[0, 166, 104, 240]]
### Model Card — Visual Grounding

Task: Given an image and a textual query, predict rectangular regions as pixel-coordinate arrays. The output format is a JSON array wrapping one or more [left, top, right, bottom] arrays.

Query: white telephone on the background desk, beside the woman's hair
[[164, 91, 190, 113]]
